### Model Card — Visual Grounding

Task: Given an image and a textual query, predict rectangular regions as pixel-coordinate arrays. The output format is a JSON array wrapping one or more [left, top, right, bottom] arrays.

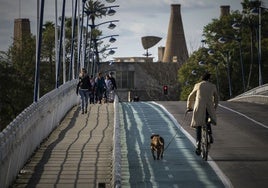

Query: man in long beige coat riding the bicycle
[[187, 72, 219, 155]]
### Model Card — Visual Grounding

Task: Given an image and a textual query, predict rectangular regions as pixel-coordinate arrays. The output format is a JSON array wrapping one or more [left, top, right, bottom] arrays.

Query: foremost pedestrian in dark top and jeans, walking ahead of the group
[[76, 68, 92, 114]]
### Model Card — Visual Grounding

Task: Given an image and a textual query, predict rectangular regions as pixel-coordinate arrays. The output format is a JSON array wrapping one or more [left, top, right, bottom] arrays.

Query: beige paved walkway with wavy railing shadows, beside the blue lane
[[12, 104, 114, 188]]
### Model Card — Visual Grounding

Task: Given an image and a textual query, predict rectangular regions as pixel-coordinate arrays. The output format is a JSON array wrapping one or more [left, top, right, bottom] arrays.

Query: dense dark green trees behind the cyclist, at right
[[178, 0, 268, 100]]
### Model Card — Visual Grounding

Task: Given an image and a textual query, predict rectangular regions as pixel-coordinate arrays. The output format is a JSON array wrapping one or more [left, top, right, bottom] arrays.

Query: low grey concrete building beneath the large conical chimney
[[99, 62, 180, 101]]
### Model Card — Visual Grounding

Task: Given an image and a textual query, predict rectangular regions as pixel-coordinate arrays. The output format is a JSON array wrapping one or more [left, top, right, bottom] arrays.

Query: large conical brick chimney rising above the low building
[[163, 4, 188, 63]]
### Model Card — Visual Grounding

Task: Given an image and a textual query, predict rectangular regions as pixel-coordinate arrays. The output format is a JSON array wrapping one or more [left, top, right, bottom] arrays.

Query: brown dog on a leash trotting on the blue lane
[[151, 134, 165, 160]]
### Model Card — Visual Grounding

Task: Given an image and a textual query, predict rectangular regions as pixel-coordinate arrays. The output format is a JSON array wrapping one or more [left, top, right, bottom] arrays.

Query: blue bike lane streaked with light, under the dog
[[119, 102, 232, 188]]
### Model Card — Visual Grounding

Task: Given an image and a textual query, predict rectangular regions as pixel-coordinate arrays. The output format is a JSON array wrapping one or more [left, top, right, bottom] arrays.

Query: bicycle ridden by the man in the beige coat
[[185, 109, 211, 161]]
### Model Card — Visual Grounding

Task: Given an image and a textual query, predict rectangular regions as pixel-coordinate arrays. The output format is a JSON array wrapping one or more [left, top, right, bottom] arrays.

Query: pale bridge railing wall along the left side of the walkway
[[0, 80, 79, 188]]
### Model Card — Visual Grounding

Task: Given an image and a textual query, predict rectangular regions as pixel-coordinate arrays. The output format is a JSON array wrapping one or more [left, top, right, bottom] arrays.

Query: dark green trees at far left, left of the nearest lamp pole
[[0, 36, 35, 130]]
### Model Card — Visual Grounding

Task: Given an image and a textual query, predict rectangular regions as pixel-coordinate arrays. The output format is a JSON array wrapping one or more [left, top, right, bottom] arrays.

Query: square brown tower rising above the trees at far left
[[13, 18, 31, 48]]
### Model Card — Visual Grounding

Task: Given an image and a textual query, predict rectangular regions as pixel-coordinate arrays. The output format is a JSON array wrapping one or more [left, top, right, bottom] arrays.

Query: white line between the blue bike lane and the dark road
[[152, 102, 233, 188]]
